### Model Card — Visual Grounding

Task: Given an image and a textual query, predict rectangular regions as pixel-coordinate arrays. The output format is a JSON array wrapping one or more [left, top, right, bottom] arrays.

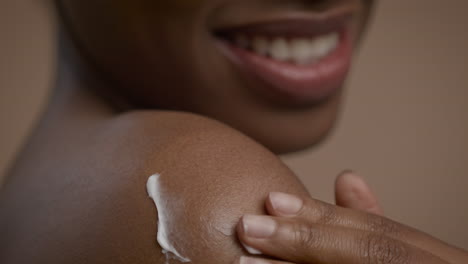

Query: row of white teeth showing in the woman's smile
[[235, 33, 339, 65]]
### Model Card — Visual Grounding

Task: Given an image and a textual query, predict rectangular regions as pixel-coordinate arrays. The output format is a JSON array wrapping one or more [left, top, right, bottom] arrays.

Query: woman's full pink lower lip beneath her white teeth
[[221, 29, 352, 103]]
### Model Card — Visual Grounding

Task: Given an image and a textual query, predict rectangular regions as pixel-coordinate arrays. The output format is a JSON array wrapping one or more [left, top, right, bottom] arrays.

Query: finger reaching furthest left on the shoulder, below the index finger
[[237, 216, 446, 264]]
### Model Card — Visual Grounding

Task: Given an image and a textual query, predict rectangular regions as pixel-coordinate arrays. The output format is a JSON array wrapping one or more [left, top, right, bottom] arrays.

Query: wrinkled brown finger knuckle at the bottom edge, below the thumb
[[360, 233, 411, 264]]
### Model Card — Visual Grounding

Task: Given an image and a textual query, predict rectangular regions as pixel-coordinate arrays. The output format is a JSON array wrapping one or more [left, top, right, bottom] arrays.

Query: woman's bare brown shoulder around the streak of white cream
[[0, 112, 306, 264]]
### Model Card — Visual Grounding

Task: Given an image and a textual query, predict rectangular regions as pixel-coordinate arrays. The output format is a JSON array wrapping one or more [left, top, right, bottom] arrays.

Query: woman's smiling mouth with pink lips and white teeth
[[215, 14, 353, 104]]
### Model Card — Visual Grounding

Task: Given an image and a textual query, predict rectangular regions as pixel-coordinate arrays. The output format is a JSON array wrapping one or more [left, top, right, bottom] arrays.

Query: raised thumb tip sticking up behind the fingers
[[335, 171, 383, 215]]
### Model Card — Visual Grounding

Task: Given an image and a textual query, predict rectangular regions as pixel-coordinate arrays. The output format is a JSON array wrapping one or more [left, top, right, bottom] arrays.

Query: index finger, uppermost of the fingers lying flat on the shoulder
[[265, 193, 464, 263]]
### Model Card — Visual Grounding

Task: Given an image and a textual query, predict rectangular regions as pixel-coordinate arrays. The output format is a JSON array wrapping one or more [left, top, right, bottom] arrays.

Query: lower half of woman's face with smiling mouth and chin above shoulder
[[60, 0, 372, 152]]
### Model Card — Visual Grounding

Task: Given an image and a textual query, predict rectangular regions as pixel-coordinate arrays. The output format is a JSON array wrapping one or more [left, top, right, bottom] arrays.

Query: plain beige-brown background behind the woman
[[0, 0, 468, 249]]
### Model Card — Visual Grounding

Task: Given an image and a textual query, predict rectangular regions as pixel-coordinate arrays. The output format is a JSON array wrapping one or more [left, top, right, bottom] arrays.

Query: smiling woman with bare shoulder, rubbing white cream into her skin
[[0, 0, 468, 264]]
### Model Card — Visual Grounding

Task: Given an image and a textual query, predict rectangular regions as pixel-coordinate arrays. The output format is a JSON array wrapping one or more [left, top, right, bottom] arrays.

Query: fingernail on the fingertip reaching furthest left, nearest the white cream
[[242, 215, 276, 238]]
